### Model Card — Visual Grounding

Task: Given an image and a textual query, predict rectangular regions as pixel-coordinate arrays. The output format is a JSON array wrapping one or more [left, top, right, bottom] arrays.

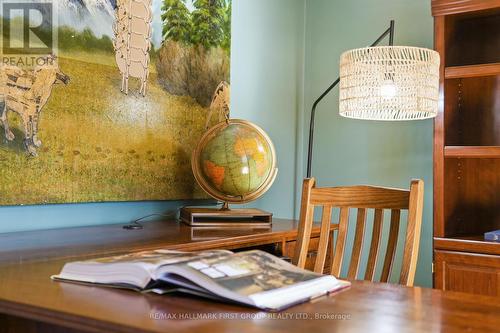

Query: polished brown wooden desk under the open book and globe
[[0, 220, 500, 333]]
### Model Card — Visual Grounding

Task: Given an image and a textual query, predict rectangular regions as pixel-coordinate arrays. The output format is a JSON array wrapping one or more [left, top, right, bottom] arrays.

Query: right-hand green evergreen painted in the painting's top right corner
[[191, 0, 227, 49]]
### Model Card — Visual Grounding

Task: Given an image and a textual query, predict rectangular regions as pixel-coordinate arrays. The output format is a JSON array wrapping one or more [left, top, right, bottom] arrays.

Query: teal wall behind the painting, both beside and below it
[[0, 0, 304, 233]]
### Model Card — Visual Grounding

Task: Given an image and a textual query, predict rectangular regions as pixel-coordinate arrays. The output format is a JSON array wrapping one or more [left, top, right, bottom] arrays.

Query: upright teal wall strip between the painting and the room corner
[[231, 0, 305, 217]]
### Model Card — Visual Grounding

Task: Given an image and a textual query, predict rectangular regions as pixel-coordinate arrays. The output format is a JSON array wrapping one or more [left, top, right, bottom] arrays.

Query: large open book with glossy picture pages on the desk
[[52, 250, 350, 311]]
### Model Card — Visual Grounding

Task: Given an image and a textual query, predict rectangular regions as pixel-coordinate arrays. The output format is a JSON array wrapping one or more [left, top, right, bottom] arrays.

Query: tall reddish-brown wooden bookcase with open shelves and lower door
[[432, 0, 500, 296]]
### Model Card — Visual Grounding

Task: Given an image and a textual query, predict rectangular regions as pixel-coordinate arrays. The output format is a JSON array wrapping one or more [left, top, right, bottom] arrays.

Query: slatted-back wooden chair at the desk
[[293, 178, 424, 286]]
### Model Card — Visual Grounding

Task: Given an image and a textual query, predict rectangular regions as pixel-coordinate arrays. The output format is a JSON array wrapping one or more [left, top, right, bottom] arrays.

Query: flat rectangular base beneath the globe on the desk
[[180, 202, 273, 228]]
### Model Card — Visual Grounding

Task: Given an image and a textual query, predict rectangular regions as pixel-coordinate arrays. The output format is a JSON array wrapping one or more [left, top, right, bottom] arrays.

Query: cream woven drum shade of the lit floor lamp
[[339, 46, 439, 120]]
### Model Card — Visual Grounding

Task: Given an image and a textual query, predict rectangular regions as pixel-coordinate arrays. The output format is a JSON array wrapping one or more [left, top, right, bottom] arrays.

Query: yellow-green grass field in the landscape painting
[[0, 53, 207, 205]]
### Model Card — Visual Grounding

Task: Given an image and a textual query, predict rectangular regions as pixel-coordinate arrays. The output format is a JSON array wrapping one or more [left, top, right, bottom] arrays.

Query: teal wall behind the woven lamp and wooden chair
[[301, 0, 433, 286]]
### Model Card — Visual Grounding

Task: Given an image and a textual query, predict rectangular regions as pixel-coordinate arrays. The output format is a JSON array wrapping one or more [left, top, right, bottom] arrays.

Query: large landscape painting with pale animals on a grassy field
[[0, 0, 231, 205]]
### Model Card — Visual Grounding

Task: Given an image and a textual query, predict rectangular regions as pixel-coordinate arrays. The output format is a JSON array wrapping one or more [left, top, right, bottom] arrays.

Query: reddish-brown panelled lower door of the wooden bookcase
[[434, 250, 500, 296]]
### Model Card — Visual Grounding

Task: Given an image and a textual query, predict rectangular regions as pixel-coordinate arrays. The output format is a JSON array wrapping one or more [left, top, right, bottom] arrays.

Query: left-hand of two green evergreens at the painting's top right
[[161, 0, 192, 43]]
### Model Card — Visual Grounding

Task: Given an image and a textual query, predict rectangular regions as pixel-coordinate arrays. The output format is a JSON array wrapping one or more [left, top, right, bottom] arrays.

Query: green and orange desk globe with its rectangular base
[[181, 119, 278, 225]]
